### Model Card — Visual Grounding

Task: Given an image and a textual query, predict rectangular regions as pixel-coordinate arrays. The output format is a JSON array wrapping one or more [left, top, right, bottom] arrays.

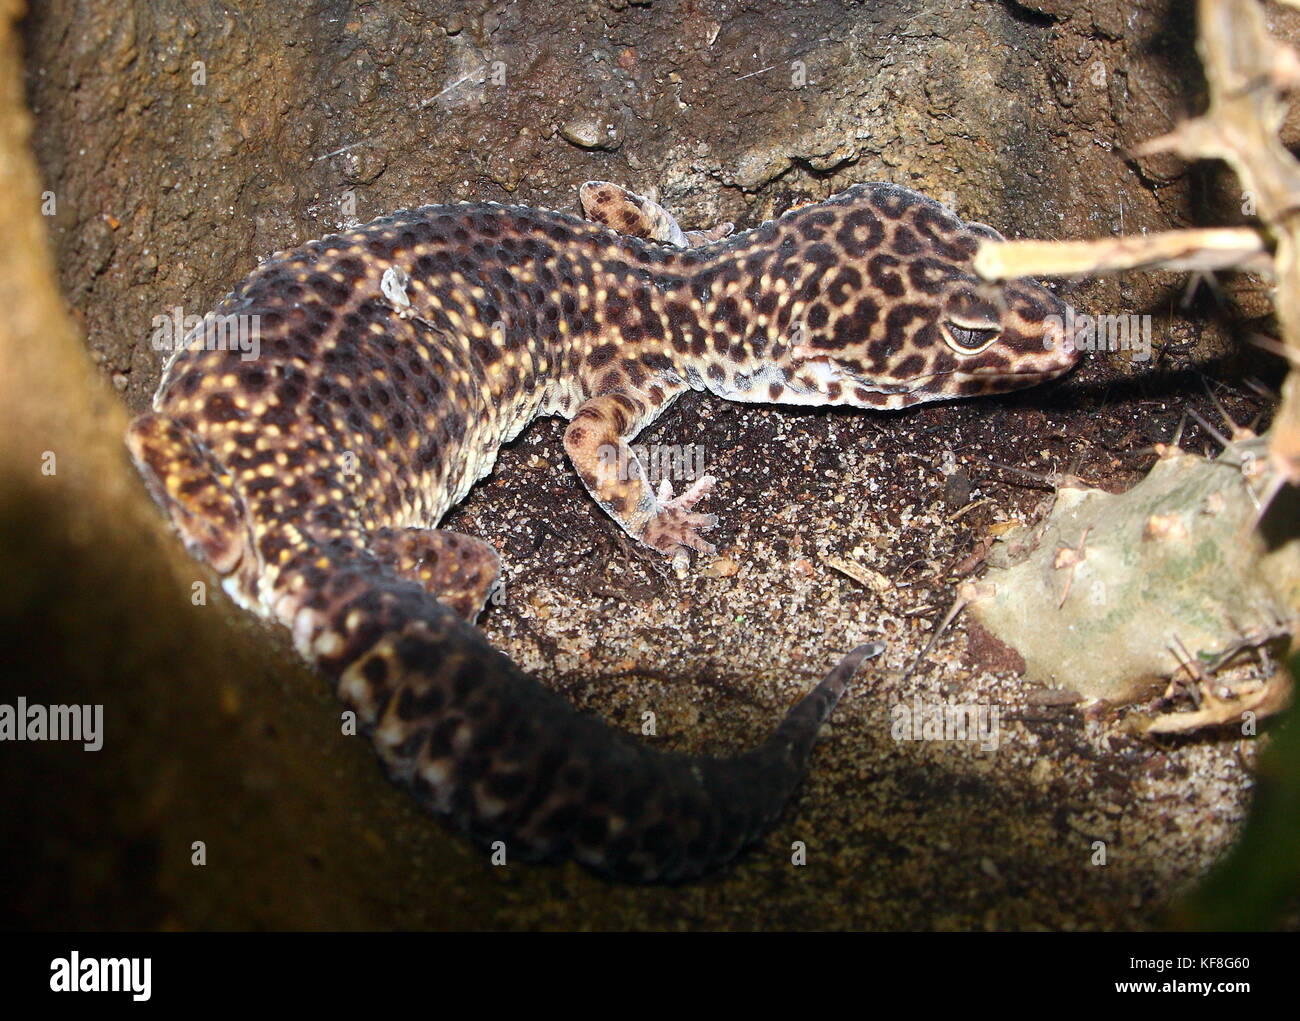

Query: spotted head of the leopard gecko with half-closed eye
[[764, 185, 1079, 407]]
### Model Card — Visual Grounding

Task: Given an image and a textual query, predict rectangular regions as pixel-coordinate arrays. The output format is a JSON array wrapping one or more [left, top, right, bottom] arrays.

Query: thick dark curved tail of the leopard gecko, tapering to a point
[[287, 550, 884, 883]]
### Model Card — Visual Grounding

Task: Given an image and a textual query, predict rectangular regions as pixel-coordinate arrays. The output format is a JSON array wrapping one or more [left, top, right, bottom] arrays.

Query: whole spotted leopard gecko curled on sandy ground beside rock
[[126, 182, 1078, 882]]
